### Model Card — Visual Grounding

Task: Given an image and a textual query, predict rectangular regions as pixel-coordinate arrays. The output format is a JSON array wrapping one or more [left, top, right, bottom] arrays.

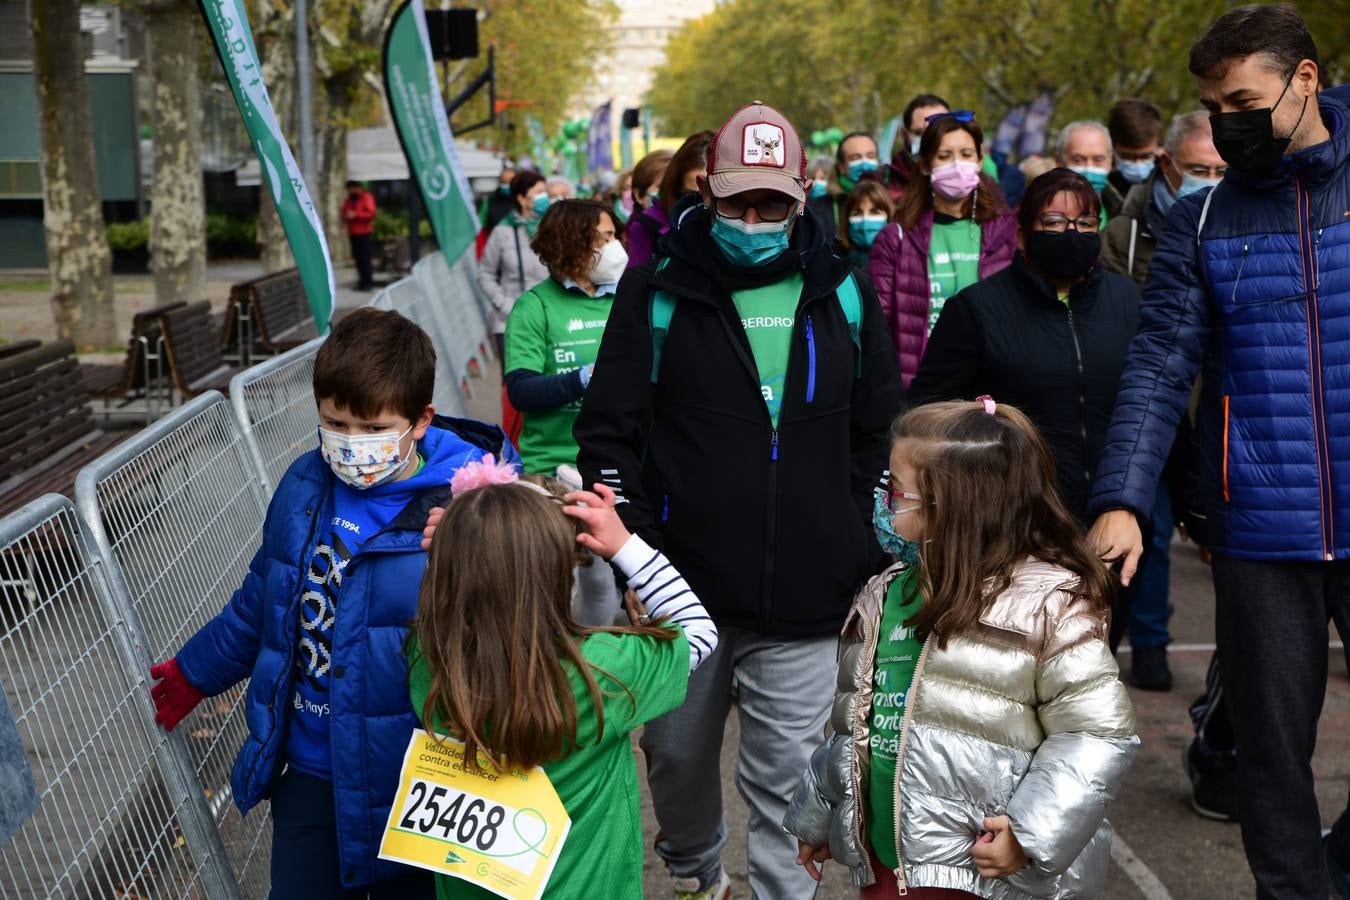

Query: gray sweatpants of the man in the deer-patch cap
[[641, 626, 837, 900]]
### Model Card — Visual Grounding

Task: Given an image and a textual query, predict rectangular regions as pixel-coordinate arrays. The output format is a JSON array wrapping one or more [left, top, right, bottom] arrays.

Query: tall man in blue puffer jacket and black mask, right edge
[[1091, 7, 1350, 900]]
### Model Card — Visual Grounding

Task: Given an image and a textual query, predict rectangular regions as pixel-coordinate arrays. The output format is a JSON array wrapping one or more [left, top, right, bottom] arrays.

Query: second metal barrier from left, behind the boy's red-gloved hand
[[76, 391, 271, 896]]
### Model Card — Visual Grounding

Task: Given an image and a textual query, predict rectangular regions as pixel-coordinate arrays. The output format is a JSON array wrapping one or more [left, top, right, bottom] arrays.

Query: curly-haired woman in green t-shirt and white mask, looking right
[[505, 200, 628, 625]]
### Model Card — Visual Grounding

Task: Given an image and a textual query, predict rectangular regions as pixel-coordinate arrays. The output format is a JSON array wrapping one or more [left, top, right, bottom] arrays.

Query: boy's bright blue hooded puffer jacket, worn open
[[176, 416, 520, 888]]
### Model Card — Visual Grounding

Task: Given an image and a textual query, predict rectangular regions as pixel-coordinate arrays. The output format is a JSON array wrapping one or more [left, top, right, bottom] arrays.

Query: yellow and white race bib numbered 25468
[[379, 729, 572, 900]]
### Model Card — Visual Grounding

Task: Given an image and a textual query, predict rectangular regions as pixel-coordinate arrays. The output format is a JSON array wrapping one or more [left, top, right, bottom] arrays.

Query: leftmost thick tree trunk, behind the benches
[[28, 0, 117, 349]]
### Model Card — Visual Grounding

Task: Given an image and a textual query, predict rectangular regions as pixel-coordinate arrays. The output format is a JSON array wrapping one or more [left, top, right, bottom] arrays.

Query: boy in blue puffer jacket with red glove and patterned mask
[[151, 308, 518, 899]]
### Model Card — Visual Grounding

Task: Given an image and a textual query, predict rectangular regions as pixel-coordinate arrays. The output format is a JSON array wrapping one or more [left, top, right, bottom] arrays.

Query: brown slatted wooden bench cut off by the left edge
[[0, 340, 127, 515]]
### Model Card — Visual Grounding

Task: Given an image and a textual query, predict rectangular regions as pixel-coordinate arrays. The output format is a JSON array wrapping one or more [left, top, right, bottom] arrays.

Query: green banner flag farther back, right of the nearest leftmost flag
[[385, 0, 478, 266]]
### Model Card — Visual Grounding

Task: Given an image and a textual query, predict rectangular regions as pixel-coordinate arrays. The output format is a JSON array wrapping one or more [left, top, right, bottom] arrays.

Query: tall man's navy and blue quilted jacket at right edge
[[1091, 93, 1350, 560]]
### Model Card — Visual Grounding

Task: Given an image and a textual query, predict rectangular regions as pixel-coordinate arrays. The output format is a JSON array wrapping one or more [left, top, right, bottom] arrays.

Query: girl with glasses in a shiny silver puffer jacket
[[784, 398, 1139, 900]]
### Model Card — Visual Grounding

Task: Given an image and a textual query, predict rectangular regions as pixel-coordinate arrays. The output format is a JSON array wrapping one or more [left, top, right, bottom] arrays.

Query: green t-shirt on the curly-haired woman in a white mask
[[505, 278, 614, 475]]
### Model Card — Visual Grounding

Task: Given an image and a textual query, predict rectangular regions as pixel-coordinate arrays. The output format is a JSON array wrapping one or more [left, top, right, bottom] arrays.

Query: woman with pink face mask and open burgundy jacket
[[868, 109, 1017, 389]]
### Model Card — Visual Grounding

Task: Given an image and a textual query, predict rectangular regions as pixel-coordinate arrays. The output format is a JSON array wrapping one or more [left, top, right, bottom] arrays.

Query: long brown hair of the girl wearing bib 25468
[[413, 479, 675, 770]]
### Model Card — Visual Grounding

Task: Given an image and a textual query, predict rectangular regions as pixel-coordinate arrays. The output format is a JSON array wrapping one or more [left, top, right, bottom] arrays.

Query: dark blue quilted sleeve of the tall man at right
[[1088, 194, 1214, 517]]
